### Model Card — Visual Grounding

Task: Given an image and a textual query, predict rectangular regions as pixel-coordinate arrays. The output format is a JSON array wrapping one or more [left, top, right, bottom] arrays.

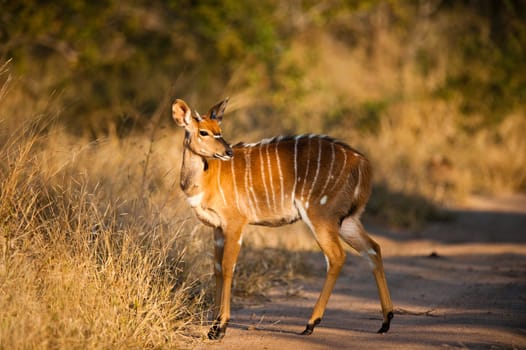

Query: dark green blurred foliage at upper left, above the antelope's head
[[0, 0, 286, 131]]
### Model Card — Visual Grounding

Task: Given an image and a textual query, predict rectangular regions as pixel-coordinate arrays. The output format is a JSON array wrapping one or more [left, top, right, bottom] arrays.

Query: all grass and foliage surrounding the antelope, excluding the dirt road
[[0, 0, 526, 349]]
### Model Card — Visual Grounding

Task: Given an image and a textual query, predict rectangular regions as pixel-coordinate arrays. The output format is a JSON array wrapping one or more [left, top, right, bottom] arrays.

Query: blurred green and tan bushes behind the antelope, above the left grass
[[0, 0, 526, 211]]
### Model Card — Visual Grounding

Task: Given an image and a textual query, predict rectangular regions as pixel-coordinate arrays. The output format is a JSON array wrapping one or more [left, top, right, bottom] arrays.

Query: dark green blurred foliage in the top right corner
[[437, 1, 526, 129]]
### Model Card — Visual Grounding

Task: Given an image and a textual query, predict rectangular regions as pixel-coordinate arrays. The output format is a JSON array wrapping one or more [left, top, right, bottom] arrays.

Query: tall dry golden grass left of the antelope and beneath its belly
[[0, 72, 310, 349]]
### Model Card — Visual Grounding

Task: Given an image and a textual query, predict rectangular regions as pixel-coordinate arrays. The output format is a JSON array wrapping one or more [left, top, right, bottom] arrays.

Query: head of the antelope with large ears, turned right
[[172, 98, 234, 160]]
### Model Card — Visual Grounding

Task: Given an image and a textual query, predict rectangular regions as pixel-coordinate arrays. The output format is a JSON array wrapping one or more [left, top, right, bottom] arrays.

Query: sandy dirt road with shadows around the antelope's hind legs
[[197, 196, 526, 350]]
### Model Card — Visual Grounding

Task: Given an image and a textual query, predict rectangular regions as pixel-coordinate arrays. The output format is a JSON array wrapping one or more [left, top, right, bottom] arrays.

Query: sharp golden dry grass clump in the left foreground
[[0, 125, 207, 349]]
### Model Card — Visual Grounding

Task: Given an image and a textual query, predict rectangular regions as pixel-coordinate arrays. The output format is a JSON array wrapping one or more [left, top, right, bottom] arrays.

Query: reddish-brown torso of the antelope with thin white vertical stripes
[[217, 135, 371, 225]]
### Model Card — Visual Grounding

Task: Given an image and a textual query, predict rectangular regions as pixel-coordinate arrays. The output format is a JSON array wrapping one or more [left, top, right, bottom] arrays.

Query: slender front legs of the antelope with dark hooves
[[208, 226, 245, 339]]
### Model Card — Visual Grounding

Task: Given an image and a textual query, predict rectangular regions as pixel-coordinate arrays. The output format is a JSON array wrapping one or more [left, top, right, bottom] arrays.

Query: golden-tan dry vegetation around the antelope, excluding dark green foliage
[[0, 1, 526, 349]]
